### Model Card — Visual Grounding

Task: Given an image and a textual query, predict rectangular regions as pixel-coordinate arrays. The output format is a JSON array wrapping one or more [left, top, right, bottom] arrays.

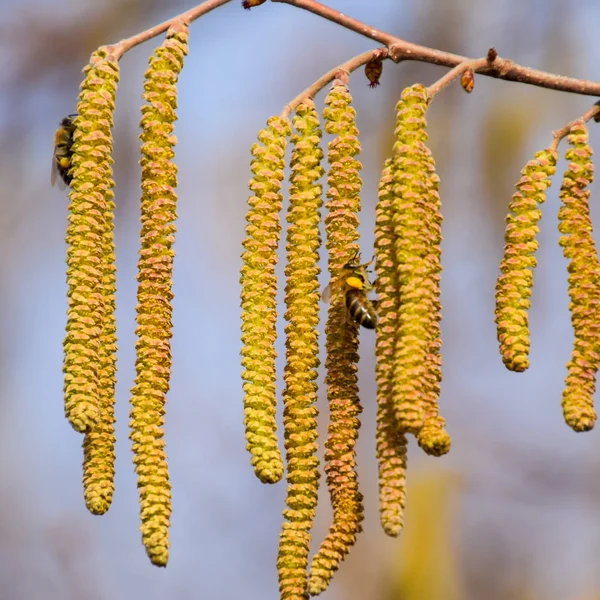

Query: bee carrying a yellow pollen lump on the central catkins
[[322, 252, 377, 329]]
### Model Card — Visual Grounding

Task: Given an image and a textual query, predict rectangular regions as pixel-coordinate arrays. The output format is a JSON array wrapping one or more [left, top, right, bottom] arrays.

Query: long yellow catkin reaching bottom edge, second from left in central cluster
[[277, 101, 323, 600]]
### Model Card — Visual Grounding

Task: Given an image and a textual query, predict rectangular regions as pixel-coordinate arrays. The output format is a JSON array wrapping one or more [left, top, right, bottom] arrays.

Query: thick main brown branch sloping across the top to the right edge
[[271, 0, 600, 96]]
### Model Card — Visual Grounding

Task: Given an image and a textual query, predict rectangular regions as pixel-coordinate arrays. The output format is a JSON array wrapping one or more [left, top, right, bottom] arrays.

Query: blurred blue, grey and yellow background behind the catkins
[[0, 0, 600, 600]]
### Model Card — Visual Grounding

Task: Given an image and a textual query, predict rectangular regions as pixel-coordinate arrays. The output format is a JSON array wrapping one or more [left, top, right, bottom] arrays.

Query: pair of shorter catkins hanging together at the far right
[[496, 121, 600, 431]]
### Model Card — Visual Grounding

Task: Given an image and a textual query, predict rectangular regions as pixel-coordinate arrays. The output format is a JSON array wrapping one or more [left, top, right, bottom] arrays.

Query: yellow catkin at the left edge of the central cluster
[[240, 117, 291, 483]]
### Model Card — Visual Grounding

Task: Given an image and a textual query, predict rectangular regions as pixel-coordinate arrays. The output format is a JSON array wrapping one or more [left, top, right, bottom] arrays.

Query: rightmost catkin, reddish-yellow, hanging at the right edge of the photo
[[558, 122, 600, 431]]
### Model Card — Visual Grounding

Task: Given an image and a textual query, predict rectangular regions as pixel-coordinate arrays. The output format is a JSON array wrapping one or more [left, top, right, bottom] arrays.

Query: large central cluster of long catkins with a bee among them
[[241, 79, 450, 600]]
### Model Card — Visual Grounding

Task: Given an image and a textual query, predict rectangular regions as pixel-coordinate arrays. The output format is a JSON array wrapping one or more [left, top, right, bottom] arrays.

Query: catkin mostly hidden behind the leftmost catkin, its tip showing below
[[83, 191, 117, 515]]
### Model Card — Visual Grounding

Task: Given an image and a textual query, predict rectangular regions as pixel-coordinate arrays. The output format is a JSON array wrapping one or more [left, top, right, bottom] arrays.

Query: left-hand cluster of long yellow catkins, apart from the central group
[[63, 24, 188, 566]]
